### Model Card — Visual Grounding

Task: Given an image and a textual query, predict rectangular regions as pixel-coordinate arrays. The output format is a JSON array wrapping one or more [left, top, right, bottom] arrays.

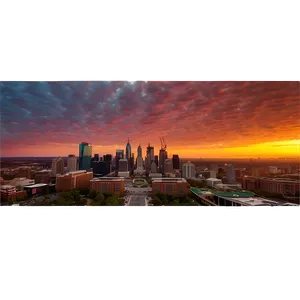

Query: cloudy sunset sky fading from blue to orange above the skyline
[[0, 79, 300, 158]]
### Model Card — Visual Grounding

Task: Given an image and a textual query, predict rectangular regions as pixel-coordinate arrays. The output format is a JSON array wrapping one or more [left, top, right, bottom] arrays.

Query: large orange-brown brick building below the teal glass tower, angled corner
[[56, 170, 93, 192]]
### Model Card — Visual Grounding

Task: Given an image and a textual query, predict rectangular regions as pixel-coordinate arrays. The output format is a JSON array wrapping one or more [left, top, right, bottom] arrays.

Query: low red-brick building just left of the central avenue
[[90, 177, 124, 194]]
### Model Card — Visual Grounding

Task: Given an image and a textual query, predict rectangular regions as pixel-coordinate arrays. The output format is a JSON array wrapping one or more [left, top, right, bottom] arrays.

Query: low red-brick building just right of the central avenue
[[152, 178, 189, 196]]
